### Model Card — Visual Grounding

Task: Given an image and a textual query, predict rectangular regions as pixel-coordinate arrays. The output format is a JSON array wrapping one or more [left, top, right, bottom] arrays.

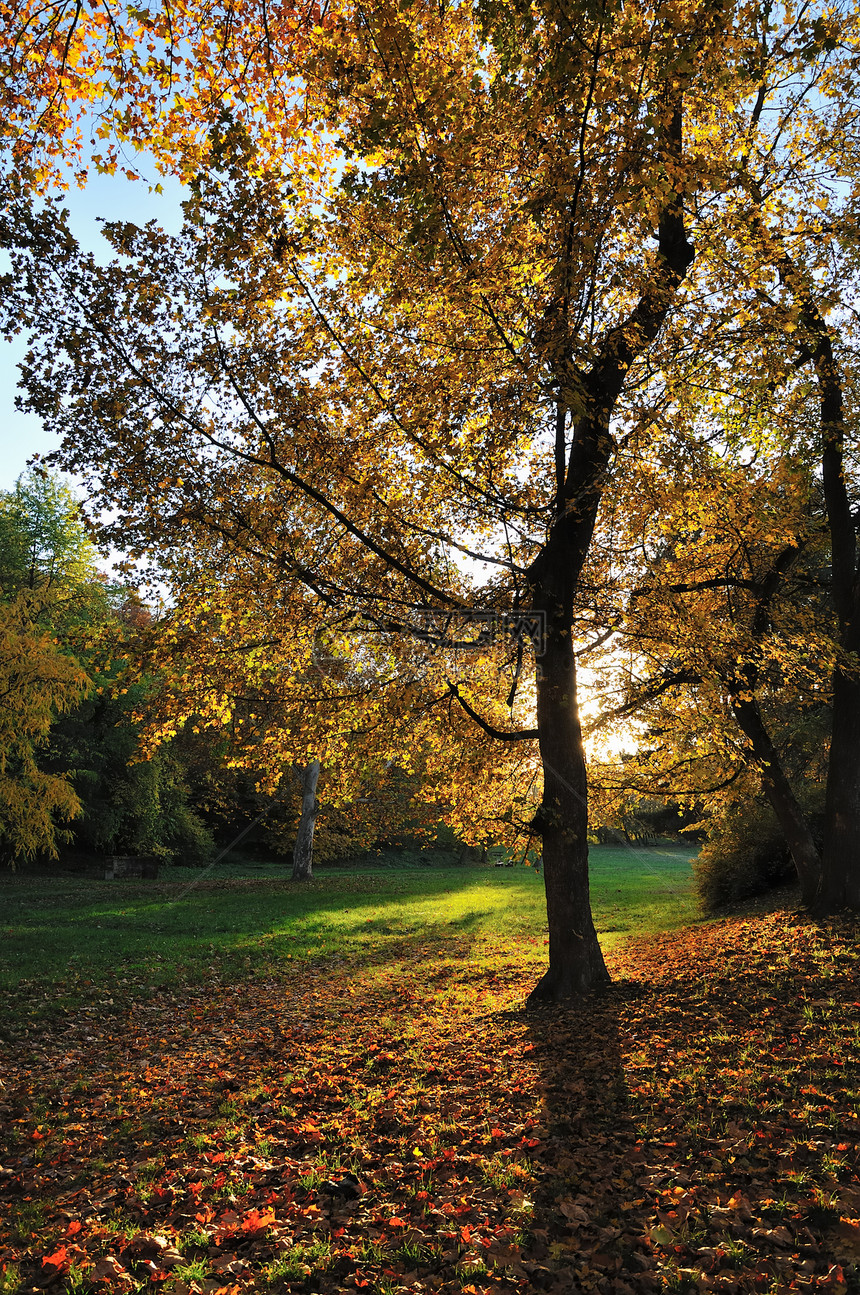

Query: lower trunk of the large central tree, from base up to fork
[[528, 625, 609, 1002]]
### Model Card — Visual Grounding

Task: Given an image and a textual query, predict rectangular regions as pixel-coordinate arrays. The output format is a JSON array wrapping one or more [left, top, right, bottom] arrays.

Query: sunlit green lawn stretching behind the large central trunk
[[0, 846, 697, 1017]]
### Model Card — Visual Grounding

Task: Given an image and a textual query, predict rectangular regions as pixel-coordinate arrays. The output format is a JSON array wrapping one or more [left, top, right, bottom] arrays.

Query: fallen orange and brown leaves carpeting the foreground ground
[[0, 913, 860, 1295]]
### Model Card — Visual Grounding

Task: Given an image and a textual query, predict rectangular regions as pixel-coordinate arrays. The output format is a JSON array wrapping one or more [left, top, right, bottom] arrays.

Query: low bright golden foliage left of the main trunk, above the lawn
[[127, 544, 536, 875]]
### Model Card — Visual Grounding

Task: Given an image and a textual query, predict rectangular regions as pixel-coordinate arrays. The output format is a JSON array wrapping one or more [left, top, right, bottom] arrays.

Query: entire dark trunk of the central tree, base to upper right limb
[[527, 95, 693, 1004]]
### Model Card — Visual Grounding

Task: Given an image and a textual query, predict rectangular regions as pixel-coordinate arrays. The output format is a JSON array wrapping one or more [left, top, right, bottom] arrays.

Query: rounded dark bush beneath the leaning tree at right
[[693, 799, 797, 912]]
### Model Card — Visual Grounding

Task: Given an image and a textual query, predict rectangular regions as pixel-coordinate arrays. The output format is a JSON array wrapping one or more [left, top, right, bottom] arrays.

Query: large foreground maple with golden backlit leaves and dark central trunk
[[6, 4, 854, 997]]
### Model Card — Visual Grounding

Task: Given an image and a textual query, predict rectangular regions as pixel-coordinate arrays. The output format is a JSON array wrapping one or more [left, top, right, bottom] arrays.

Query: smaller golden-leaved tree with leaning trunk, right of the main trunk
[[588, 440, 833, 903]]
